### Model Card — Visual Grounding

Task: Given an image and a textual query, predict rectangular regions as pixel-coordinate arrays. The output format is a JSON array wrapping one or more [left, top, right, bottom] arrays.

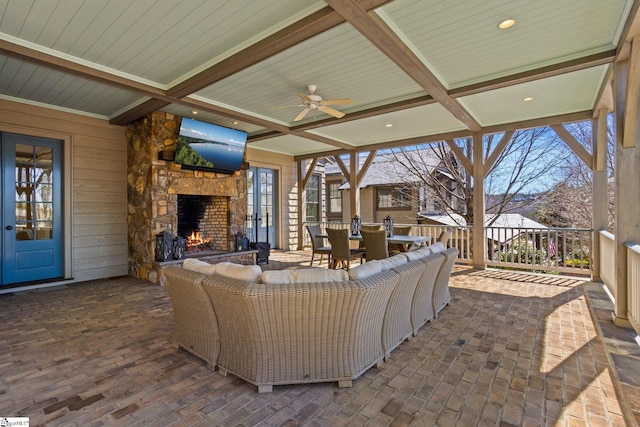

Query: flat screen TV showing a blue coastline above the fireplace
[[174, 117, 247, 173]]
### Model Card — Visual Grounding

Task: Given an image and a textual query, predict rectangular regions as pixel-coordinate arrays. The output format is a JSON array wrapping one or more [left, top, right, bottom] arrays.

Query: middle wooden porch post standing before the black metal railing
[[471, 132, 487, 270]]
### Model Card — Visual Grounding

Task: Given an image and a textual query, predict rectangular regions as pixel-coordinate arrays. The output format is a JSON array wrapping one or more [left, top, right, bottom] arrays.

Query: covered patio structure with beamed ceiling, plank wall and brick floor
[[0, 0, 640, 426]]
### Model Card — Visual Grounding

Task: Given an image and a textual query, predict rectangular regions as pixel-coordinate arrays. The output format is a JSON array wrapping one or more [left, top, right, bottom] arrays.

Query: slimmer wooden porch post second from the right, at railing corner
[[591, 109, 609, 282]]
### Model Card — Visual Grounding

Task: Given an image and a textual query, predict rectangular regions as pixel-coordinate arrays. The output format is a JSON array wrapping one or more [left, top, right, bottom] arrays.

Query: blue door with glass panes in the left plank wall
[[0, 133, 64, 285]]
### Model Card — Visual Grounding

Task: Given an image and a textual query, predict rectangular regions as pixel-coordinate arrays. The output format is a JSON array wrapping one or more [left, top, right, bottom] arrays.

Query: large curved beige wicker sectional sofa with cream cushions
[[165, 245, 457, 392]]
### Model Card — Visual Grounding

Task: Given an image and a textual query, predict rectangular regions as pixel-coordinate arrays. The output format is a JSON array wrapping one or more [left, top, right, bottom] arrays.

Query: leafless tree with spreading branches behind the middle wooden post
[[382, 128, 569, 225]]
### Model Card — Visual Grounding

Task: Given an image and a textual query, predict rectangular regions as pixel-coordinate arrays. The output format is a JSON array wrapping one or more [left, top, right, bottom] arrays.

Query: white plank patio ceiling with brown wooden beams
[[0, 0, 640, 159]]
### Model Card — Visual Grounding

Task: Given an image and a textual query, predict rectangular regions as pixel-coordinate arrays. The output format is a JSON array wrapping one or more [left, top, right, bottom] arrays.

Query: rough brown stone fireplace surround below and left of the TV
[[126, 111, 247, 282]]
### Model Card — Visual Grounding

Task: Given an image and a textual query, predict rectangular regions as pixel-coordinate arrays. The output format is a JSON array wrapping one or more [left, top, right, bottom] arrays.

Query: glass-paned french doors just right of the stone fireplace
[[247, 167, 278, 248]]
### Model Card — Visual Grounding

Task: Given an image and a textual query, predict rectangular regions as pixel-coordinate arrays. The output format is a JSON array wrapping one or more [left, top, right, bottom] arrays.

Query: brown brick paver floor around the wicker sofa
[[0, 252, 640, 426]]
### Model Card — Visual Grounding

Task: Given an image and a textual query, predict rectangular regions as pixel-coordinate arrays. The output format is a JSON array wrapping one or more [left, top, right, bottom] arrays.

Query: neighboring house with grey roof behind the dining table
[[324, 149, 462, 224]]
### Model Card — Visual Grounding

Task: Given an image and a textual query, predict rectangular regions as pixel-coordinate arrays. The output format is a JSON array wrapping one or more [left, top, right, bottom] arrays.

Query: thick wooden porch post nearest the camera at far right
[[612, 42, 640, 327]]
